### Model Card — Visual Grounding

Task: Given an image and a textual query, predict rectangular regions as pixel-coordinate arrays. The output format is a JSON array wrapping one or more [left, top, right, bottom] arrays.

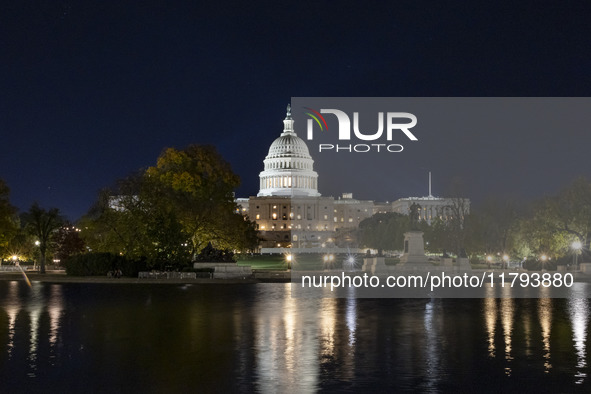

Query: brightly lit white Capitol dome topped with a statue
[[257, 105, 320, 197]]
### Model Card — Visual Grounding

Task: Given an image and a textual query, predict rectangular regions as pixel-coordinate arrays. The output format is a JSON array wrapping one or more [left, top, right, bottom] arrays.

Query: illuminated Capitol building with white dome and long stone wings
[[236, 105, 469, 250]]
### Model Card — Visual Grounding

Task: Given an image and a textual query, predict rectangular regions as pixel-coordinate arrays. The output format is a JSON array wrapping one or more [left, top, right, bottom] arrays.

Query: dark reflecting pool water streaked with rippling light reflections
[[0, 282, 591, 392]]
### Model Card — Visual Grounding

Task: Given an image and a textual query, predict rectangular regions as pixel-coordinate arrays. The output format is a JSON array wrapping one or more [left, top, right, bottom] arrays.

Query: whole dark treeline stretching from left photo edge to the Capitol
[[0, 145, 258, 271]]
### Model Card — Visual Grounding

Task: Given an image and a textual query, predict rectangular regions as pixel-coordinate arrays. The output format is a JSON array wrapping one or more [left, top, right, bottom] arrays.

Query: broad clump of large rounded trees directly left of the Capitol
[[79, 145, 258, 268]]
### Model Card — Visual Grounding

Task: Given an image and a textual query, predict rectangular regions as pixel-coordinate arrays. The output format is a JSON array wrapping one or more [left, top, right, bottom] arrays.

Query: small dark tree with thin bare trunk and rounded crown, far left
[[23, 203, 63, 274]]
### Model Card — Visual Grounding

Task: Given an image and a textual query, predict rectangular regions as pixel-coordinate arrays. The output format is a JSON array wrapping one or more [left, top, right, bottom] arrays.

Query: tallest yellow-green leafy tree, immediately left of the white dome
[[145, 145, 256, 251]]
